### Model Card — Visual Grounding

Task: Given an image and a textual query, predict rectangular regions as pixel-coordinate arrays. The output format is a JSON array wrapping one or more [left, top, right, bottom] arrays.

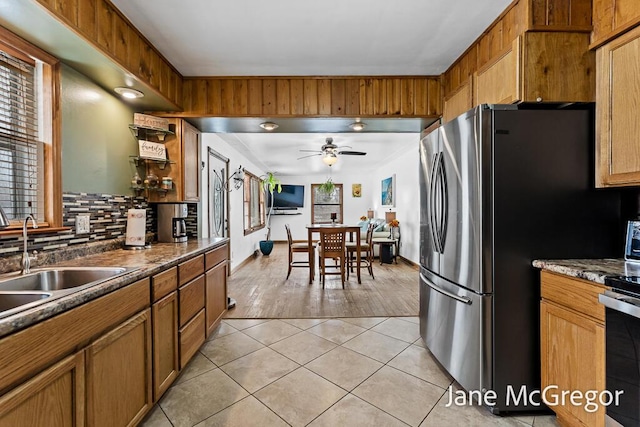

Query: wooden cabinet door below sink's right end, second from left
[[87, 309, 153, 427]]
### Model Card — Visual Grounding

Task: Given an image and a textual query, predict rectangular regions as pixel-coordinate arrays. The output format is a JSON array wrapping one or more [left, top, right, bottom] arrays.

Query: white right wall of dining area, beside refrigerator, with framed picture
[[370, 146, 420, 264]]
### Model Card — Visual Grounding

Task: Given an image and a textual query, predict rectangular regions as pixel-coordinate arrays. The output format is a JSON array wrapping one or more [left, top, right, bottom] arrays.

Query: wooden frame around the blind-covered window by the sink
[[0, 26, 60, 235]]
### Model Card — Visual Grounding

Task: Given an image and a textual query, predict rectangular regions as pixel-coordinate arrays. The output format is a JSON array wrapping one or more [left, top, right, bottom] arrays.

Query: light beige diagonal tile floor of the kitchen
[[142, 317, 557, 427]]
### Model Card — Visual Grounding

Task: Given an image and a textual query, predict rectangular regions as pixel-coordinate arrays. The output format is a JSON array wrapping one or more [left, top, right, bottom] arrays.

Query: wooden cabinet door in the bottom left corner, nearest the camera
[[0, 352, 85, 427]]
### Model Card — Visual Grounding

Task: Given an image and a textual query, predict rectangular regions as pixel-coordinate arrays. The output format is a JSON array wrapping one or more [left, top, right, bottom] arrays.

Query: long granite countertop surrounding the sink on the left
[[0, 237, 229, 336]]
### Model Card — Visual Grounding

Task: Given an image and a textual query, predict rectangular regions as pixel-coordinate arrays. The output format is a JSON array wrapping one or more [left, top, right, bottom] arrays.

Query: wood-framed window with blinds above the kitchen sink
[[0, 28, 62, 227]]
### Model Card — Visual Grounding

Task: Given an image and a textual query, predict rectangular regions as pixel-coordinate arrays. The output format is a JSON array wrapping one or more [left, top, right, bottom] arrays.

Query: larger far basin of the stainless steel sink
[[0, 267, 129, 291]]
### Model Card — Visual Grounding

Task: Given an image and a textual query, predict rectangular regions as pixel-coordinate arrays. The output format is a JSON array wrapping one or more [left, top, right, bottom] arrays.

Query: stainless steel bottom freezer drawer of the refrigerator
[[420, 268, 493, 391]]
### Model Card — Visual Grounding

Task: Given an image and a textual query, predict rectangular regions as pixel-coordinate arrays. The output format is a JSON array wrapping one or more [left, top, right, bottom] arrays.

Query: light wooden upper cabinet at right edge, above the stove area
[[596, 27, 640, 187]]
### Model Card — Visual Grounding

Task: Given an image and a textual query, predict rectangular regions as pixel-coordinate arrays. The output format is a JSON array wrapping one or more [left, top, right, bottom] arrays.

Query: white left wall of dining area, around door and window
[[199, 133, 266, 271]]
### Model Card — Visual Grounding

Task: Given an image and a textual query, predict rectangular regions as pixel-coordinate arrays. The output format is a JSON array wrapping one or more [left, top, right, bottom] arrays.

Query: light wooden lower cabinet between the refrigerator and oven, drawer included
[[540, 272, 606, 427]]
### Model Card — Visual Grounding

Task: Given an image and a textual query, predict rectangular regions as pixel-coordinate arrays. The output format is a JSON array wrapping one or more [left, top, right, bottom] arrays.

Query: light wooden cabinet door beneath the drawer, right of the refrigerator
[[540, 300, 605, 426]]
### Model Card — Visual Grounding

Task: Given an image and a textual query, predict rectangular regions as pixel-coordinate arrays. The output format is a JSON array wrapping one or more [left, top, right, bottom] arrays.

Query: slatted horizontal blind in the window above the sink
[[0, 50, 44, 221]]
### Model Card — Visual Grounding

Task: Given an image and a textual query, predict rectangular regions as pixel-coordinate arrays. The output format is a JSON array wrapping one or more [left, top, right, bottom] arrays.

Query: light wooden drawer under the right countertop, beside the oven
[[540, 271, 608, 323]]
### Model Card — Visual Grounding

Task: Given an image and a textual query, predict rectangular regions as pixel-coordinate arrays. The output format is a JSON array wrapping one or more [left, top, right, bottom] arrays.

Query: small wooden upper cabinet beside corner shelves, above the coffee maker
[[147, 119, 200, 202]]
